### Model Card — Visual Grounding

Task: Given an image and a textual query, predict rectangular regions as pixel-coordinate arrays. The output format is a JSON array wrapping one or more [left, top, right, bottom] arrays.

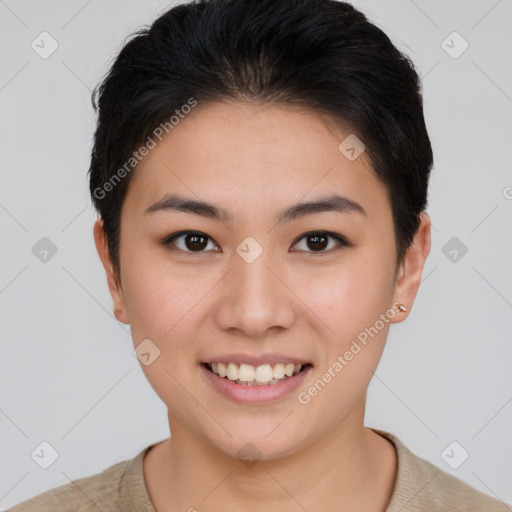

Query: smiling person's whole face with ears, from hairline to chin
[[95, 103, 429, 460]]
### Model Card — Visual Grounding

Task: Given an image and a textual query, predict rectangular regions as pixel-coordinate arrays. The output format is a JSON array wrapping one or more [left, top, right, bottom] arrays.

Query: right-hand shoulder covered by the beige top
[[372, 429, 512, 512]]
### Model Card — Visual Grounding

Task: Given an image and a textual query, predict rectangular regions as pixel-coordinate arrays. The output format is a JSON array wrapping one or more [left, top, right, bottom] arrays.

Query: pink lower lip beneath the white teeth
[[199, 364, 313, 404]]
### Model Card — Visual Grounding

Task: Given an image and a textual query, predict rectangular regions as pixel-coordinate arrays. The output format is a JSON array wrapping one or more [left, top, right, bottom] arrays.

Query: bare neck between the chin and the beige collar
[[144, 406, 396, 512]]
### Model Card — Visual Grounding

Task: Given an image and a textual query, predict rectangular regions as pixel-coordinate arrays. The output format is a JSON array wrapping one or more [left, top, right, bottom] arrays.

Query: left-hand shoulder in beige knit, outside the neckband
[[7, 450, 145, 512]]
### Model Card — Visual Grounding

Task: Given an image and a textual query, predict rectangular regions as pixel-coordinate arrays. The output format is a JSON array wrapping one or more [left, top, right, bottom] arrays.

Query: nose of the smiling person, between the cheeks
[[215, 246, 298, 338]]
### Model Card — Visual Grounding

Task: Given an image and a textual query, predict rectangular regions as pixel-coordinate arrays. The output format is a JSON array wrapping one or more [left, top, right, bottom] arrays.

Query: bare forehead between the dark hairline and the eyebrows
[[123, 102, 389, 222]]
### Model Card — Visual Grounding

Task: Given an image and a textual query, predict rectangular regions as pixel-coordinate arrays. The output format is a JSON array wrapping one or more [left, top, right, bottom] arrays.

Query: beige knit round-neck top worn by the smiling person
[[8, 428, 512, 512]]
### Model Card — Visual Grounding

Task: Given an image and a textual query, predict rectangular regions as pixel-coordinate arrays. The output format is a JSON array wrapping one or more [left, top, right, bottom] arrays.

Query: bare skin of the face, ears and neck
[[94, 98, 430, 512]]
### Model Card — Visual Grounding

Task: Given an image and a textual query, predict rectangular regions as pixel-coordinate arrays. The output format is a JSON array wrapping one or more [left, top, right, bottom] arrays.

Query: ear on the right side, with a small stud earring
[[391, 212, 431, 323]]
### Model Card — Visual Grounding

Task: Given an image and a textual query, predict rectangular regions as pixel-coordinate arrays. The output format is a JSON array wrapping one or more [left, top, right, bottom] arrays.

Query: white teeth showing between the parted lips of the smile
[[201, 363, 312, 386]]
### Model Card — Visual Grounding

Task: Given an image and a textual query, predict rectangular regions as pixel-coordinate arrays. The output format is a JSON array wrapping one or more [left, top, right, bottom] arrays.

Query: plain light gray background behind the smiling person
[[0, 0, 512, 510]]
